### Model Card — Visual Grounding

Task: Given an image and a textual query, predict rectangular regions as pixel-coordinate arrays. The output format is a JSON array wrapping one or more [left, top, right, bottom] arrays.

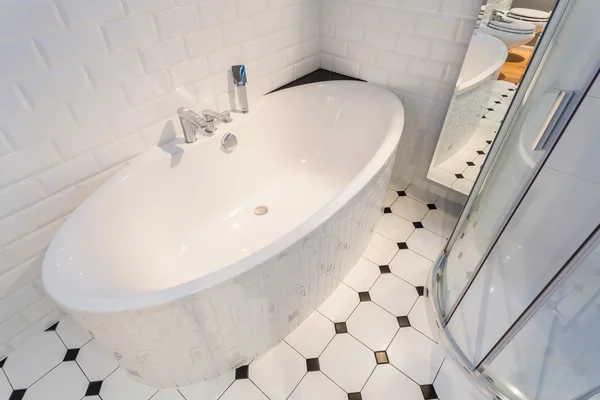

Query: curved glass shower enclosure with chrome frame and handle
[[429, 0, 600, 400]]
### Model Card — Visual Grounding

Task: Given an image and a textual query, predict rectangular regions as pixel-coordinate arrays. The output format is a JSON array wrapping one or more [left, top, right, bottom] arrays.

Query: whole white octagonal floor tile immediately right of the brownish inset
[[387, 327, 444, 385]]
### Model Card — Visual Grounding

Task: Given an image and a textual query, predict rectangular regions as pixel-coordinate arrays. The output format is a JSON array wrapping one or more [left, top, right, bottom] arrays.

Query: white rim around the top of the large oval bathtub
[[41, 81, 404, 314]]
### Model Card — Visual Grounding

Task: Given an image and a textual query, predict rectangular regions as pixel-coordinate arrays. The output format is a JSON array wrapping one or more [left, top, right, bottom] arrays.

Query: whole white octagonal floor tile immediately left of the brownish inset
[[319, 334, 375, 393]]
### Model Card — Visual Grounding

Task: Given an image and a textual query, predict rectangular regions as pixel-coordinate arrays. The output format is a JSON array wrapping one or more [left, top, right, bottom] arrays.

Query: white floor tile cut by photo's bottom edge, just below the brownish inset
[[361, 364, 422, 400]]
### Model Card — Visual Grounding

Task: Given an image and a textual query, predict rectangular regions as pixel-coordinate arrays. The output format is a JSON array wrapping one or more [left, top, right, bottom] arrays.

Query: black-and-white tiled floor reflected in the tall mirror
[[427, 81, 517, 194]]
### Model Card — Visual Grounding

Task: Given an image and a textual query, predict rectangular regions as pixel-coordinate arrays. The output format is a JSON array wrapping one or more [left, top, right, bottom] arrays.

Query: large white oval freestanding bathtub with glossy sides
[[42, 82, 404, 387]]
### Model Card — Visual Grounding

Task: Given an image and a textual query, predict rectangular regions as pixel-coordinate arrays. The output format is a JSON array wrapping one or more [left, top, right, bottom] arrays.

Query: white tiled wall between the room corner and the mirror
[[321, 0, 481, 181]]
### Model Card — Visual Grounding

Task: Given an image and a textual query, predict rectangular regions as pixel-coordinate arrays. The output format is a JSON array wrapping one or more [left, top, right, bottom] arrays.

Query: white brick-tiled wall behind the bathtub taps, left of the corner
[[0, 0, 320, 358]]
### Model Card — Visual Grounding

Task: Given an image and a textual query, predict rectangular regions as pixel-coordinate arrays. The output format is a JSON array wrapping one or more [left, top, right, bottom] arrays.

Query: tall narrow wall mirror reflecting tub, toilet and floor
[[427, 0, 555, 194]]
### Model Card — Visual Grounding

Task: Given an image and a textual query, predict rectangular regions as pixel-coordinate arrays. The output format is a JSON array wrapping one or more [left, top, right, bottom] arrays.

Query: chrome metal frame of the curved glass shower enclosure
[[427, 0, 600, 400]]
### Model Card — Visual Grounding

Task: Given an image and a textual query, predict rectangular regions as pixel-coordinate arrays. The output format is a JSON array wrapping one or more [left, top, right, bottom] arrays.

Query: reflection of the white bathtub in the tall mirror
[[432, 32, 508, 166]]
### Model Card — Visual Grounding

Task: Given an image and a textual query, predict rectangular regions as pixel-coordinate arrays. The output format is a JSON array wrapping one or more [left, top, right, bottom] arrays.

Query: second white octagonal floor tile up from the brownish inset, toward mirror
[[369, 274, 419, 317]]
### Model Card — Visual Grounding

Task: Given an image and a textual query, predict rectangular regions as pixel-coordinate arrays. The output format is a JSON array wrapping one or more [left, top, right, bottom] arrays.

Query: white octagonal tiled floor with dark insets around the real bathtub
[[0, 183, 481, 400]]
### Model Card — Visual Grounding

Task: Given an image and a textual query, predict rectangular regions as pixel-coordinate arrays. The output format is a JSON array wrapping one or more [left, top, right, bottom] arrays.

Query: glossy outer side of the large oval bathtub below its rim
[[72, 151, 395, 388]]
